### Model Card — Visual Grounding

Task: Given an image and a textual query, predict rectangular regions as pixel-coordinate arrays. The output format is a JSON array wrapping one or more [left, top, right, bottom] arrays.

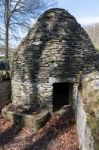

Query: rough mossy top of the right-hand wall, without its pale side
[[80, 72, 99, 150]]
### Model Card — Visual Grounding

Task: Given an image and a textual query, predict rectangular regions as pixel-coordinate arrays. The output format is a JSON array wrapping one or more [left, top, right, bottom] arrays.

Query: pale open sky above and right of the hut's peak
[[0, 0, 99, 46]]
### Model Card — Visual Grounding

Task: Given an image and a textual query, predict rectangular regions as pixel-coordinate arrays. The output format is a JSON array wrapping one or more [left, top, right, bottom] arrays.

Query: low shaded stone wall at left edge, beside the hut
[[0, 81, 11, 111]]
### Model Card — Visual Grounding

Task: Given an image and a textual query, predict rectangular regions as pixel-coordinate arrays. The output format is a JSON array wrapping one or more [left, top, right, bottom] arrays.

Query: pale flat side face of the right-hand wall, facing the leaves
[[76, 93, 94, 150]]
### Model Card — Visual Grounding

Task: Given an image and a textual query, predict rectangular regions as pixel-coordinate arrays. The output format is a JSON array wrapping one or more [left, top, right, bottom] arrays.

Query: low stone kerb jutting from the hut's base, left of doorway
[[2, 106, 51, 131]]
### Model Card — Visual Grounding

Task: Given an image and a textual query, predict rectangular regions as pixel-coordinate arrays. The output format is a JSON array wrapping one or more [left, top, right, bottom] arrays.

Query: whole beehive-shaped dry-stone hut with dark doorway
[[12, 8, 96, 110]]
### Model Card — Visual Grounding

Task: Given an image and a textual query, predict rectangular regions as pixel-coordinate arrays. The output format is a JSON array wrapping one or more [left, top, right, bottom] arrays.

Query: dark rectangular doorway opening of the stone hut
[[53, 82, 70, 111]]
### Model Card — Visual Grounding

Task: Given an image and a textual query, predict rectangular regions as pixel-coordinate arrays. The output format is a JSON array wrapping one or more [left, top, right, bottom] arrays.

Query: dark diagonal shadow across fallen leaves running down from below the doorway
[[24, 110, 75, 150]]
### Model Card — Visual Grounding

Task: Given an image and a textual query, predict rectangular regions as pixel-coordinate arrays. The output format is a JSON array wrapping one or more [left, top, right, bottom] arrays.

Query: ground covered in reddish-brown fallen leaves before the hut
[[0, 113, 79, 150]]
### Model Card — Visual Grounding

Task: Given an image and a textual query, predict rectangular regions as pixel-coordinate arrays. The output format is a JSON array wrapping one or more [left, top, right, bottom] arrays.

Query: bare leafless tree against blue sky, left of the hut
[[0, 0, 56, 70]]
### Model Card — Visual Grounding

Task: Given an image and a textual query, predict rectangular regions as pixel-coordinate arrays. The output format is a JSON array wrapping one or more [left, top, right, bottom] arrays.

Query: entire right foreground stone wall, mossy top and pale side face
[[76, 72, 99, 150]]
